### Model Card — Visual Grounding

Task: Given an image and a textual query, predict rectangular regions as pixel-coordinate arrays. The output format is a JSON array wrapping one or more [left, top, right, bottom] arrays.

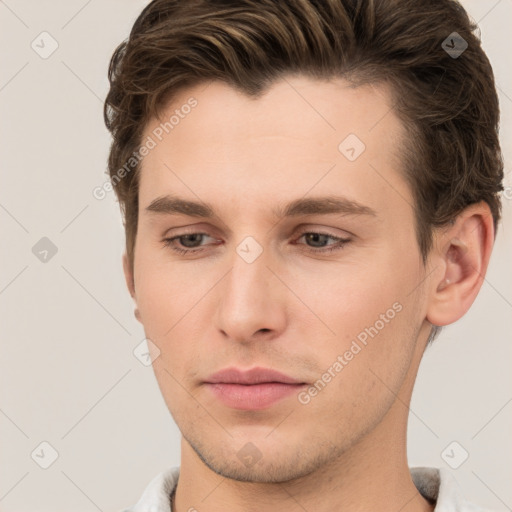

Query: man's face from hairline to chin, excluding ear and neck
[[134, 77, 429, 482]]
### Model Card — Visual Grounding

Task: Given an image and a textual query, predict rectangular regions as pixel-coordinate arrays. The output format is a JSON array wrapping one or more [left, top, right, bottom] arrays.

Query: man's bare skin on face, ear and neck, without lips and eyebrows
[[123, 76, 494, 512]]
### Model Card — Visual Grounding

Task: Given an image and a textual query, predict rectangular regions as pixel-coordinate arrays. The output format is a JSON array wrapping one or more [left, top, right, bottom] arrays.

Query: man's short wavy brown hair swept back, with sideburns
[[104, 0, 503, 292]]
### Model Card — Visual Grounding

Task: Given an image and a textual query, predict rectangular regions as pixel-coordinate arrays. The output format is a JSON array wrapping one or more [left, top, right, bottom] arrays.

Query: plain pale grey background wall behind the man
[[0, 0, 512, 512]]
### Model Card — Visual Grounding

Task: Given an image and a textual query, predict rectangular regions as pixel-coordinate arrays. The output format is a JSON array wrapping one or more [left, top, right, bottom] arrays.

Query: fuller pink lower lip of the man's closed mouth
[[206, 382, 305, 410]]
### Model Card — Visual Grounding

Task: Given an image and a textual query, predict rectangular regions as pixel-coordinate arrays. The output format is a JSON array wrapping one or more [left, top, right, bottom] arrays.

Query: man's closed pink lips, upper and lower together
[[205, 367, 306, 410]]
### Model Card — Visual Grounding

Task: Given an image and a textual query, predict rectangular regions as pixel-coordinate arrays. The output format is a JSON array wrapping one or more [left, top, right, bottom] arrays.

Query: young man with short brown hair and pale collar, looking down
[[105, 0, 503, 512]]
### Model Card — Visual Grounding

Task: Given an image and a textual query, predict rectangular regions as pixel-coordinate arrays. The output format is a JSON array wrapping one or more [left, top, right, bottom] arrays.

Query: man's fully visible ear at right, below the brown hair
[[427, 201, 494, 326]]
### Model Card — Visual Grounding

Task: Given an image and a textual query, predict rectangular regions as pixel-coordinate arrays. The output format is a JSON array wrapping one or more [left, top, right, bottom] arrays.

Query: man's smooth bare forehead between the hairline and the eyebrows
[[140, 76, 407, 220]]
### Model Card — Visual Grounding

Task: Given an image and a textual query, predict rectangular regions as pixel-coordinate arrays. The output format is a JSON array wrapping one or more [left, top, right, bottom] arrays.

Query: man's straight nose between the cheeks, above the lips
[[215, 239, 287, 343]]
